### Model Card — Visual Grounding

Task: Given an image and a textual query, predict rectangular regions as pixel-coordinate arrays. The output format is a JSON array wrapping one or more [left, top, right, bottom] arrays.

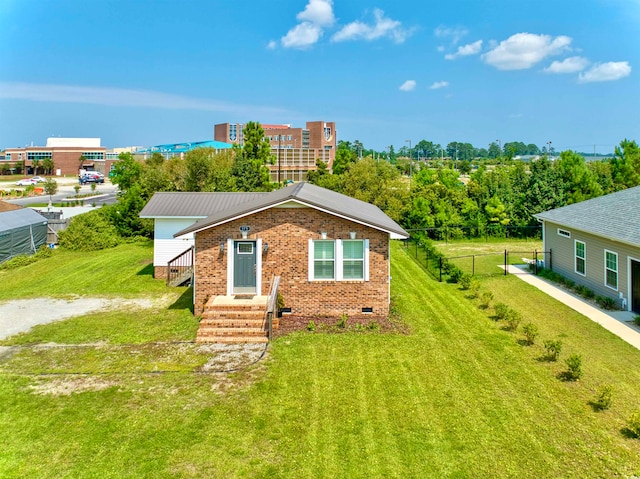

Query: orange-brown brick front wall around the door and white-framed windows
[[194, 208, 389, 321]]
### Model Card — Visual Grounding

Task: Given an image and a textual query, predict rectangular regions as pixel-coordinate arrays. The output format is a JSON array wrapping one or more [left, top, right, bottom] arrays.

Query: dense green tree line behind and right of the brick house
[[309, 140, 640, 240]]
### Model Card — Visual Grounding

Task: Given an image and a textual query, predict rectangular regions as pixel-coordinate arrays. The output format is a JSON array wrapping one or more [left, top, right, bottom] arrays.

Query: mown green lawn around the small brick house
[[0, 242, 640, 478]]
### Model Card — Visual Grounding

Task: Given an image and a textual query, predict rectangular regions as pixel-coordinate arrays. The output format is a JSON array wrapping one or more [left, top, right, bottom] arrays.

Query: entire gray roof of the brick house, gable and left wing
[[152, 182, 409, 238]]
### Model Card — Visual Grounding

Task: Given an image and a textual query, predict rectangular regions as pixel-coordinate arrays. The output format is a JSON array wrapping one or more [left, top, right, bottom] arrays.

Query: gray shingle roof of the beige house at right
[[534, 186, 640, 246]]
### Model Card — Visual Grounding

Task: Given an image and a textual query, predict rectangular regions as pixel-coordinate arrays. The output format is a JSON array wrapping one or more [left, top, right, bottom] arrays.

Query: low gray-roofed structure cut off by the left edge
[[0, 201, 47, 263]]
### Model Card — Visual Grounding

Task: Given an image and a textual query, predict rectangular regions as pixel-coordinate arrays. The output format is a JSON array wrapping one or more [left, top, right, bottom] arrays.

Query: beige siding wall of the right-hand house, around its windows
[[544, 221, 640, 306]]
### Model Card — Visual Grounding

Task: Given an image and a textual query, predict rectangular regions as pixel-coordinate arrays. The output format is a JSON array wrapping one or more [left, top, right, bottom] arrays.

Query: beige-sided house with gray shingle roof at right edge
[[534, 186, 640, 313]]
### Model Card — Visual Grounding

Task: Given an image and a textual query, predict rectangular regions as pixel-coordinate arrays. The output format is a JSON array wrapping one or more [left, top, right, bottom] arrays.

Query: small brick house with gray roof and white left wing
[[141, 182, 409, 317]]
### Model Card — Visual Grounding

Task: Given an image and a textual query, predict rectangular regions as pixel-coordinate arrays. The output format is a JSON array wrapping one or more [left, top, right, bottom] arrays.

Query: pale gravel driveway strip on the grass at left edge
[[0, 298, 154, 339]]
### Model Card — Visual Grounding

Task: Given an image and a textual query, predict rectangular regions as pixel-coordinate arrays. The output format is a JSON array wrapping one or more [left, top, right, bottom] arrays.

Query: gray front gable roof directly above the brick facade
[[174, 182, 409, 238]]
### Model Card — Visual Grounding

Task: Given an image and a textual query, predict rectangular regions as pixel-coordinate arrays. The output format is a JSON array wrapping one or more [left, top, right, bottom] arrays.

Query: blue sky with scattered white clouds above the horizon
[[0, 0, 640, 153]]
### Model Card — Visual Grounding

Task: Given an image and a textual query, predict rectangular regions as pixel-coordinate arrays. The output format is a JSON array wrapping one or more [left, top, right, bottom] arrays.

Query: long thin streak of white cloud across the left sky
[[0, 82, 286, 116]]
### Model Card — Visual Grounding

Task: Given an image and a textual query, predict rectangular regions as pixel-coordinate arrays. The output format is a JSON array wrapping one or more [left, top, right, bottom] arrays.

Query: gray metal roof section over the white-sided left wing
[[140, 192, 267, 218]]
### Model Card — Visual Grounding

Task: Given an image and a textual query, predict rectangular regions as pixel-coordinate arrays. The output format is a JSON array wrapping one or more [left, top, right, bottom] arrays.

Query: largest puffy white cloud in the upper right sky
[[482, 33, 571, 70]]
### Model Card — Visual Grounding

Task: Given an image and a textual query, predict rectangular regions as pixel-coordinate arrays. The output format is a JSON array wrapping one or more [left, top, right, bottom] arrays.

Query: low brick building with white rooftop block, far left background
[[4, 138, 114, 175]]
